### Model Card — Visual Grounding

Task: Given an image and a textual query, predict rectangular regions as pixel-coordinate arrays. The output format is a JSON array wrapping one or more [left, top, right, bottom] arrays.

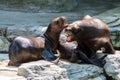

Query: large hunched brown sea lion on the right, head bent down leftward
[[65, 15, 115, 58]]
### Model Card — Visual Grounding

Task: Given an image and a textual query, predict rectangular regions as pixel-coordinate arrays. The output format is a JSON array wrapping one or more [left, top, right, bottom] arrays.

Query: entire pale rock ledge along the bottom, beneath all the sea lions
[[0, 51, 120, 80]]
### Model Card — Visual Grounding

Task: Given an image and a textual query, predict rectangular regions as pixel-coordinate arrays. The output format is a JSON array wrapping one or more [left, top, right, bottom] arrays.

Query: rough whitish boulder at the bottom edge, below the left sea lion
[[18, 60, 68, 80]]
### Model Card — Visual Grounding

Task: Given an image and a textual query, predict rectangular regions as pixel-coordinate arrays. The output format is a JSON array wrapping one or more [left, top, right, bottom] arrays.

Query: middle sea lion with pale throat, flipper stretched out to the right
[[58, 33, 106, 67]]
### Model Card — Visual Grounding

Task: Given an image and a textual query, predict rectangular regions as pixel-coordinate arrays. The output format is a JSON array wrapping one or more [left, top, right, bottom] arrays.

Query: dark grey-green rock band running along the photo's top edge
[[0, 0, 120, 14]]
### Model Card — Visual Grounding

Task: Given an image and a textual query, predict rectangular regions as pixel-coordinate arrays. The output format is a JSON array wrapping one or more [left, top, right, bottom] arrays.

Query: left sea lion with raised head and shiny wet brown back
[[8, 17, 66, 66]]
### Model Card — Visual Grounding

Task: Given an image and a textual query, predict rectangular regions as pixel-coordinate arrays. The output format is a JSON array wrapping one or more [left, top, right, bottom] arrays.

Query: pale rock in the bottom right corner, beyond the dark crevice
[[104, 51, 120, 80]]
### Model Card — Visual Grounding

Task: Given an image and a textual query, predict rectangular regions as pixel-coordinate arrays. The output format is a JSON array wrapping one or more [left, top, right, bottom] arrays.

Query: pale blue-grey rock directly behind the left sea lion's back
[[7, 26, 47, 39]]
